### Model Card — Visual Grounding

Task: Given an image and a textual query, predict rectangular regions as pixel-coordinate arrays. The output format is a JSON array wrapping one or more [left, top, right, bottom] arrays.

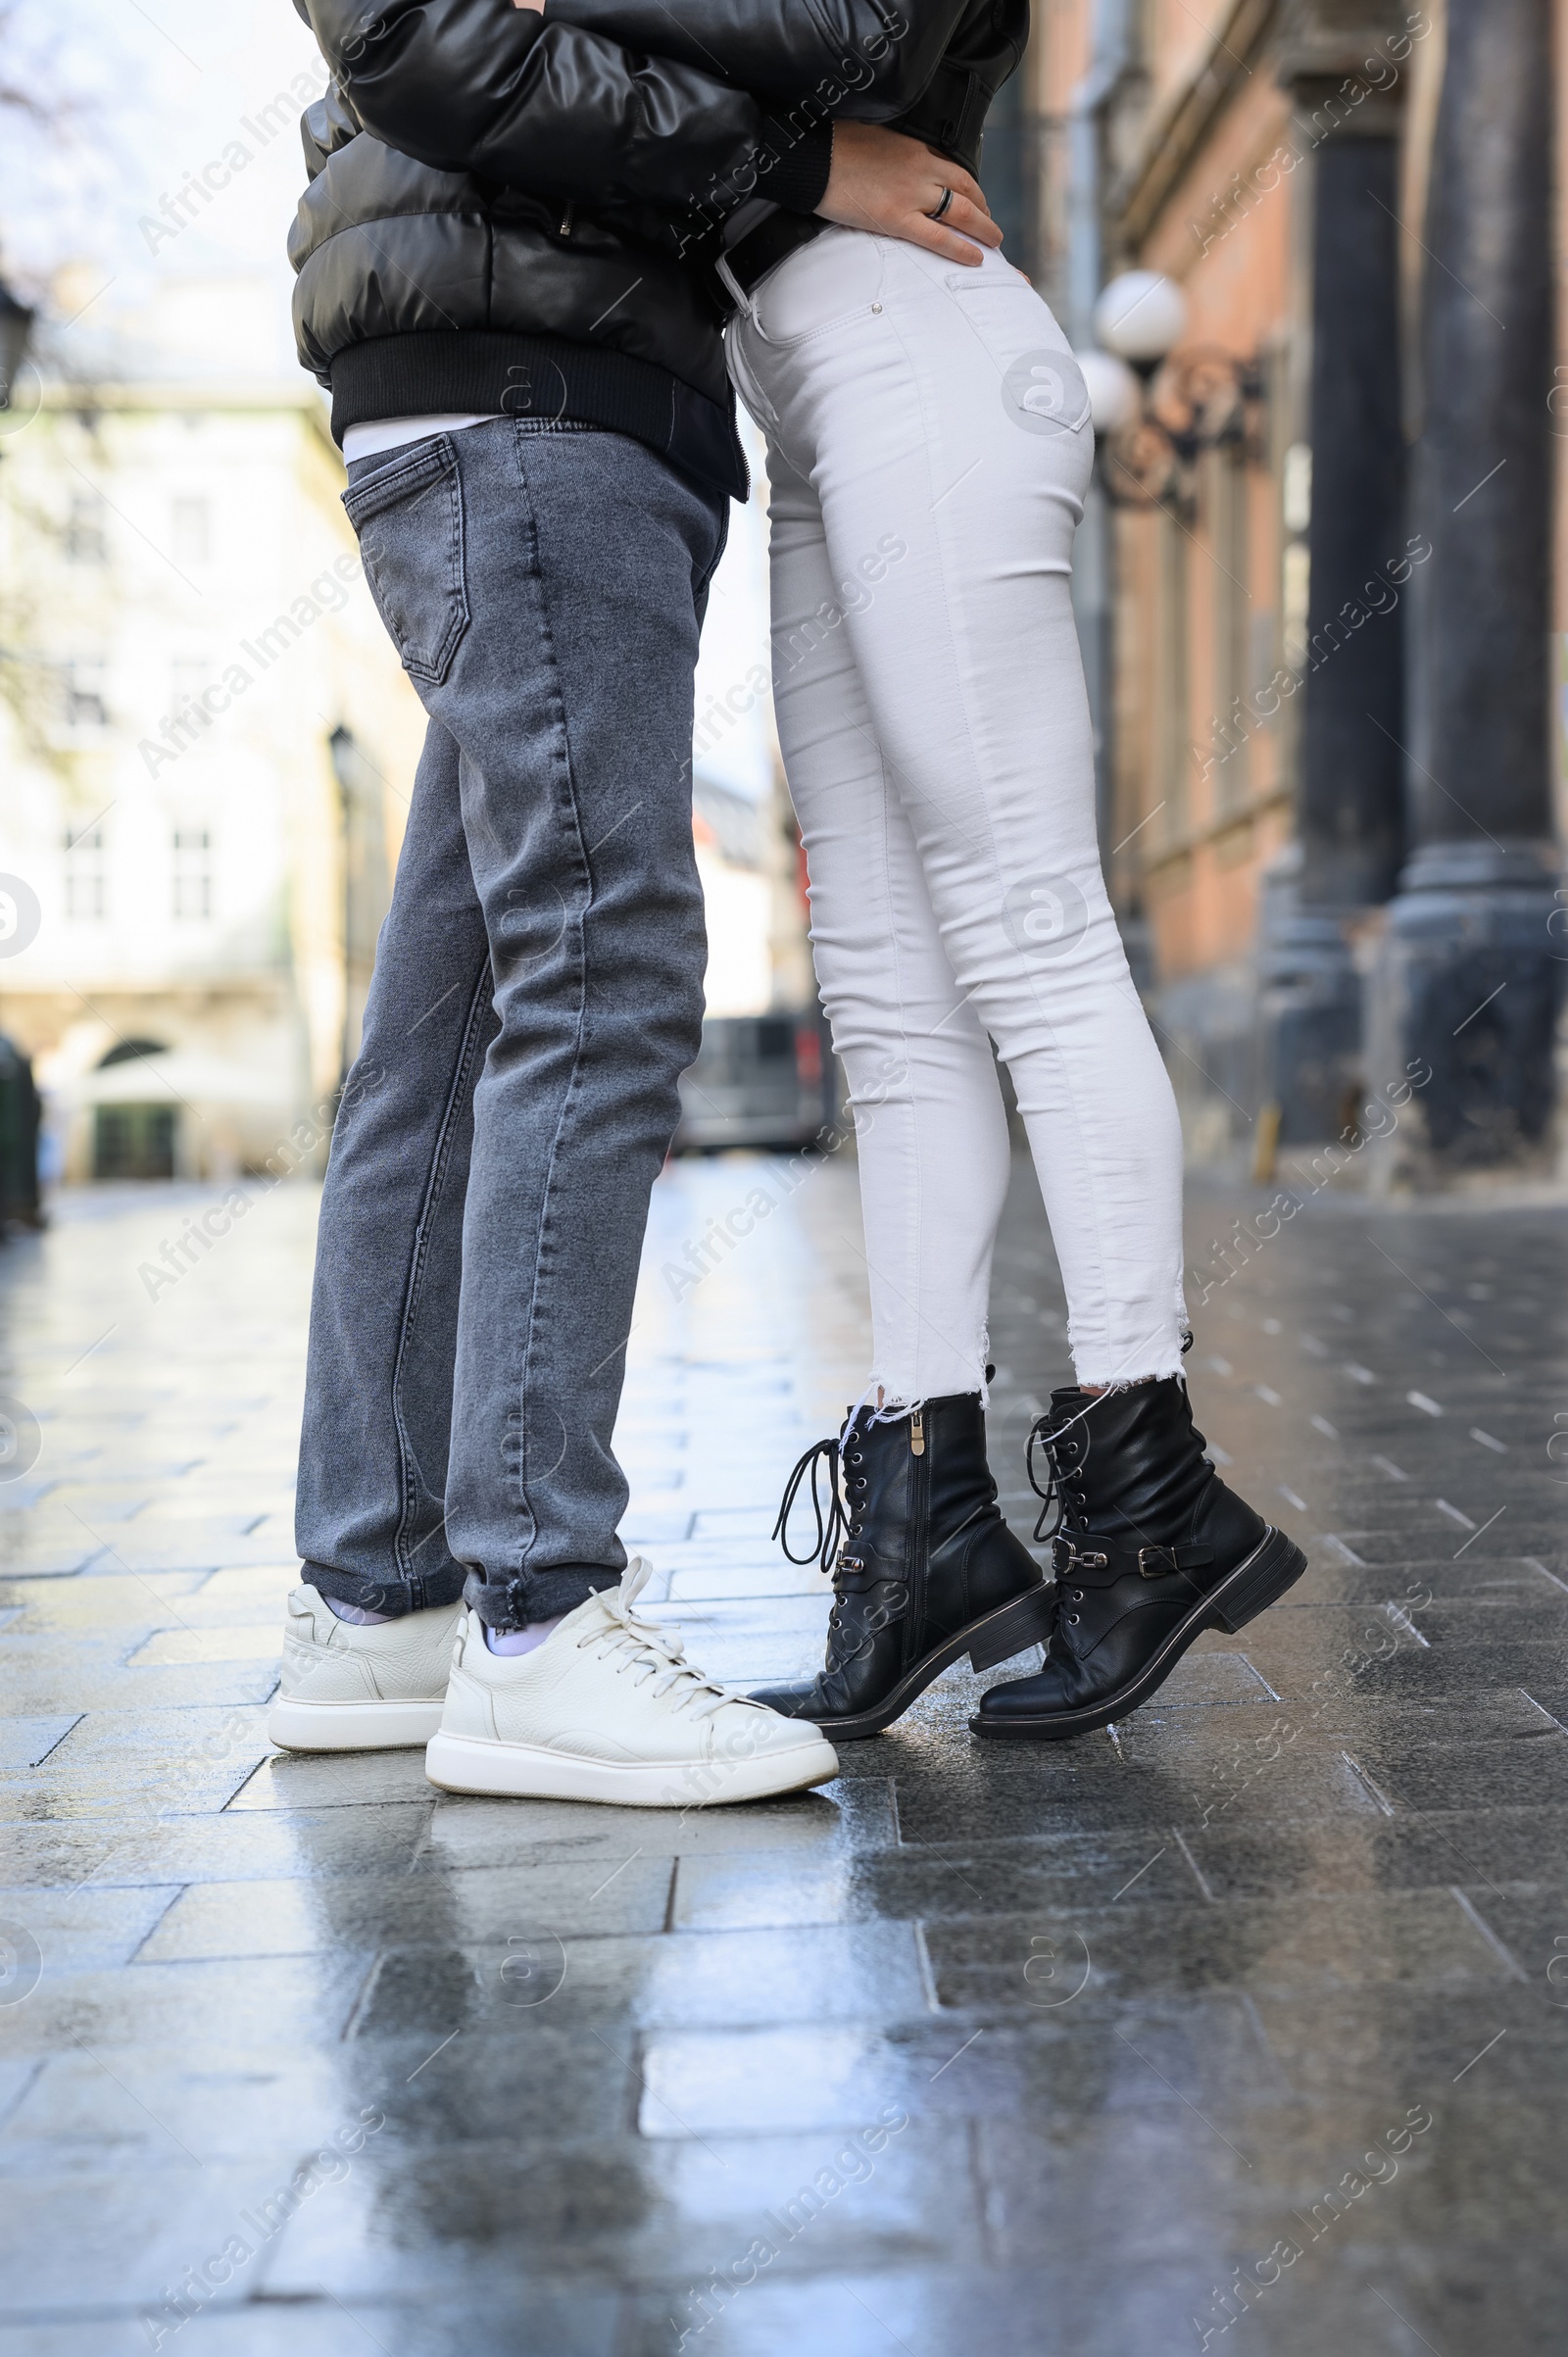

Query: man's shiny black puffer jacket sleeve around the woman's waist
[[295, 0, 830, 217]]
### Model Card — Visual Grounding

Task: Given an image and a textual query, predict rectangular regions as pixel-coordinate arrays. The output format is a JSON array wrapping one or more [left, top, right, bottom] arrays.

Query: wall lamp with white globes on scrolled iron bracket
[[1078, 271, 1264, 509]]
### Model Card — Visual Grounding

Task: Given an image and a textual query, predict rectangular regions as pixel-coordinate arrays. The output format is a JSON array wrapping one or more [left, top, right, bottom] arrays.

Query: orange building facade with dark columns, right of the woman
[[986, 0, 1568, 1183]]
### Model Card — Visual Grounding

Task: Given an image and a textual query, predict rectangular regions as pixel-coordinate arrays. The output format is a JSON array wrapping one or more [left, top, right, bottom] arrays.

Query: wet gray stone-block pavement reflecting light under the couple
[[0, 1159, 1568, 2357]]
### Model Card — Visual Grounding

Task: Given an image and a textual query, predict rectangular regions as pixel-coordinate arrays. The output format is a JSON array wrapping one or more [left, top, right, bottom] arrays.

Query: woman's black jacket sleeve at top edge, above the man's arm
[[537, 0, 966, 123]]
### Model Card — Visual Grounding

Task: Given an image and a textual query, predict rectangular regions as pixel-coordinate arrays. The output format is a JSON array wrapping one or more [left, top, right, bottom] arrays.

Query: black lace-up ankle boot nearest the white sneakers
[[755, 1391, 1052, 1742]]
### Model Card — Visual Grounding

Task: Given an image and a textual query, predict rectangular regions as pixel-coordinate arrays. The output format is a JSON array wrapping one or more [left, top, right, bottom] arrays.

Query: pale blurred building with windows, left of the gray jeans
[[0, 382, 422, 1179]]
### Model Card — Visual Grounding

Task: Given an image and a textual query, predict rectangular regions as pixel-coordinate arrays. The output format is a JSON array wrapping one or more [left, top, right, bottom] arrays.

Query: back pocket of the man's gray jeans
[[342, 434, 469, 688]]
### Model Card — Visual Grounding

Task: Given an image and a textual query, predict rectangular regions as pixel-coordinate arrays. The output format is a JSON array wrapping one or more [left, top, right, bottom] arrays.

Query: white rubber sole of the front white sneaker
[[424, 1735, 840, 1810]]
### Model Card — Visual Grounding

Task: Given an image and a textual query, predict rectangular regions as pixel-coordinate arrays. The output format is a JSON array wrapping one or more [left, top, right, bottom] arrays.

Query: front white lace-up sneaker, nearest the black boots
[[424, 1555, 840, 1808]]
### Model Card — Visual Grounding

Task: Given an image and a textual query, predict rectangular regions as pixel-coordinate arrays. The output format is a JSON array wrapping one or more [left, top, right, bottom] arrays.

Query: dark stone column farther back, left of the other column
[[1259, 7, 1410, 1143]]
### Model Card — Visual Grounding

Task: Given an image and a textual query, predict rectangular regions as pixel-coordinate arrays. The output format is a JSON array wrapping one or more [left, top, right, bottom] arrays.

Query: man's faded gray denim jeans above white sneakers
[[297, 419, 726, 1629]]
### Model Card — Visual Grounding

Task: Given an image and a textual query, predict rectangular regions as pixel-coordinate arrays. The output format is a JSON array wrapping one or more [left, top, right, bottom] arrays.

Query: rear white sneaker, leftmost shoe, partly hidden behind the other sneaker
[[267, 1589, 463, 1751]]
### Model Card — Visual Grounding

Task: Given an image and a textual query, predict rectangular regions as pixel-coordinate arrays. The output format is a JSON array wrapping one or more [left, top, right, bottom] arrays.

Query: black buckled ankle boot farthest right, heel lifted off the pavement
[[969, 1374, 1306, 1742]]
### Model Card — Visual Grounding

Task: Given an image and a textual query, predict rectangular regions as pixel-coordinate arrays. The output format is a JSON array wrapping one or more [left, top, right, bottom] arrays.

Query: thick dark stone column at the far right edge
[[1367, 0, 1566, 1179]]
